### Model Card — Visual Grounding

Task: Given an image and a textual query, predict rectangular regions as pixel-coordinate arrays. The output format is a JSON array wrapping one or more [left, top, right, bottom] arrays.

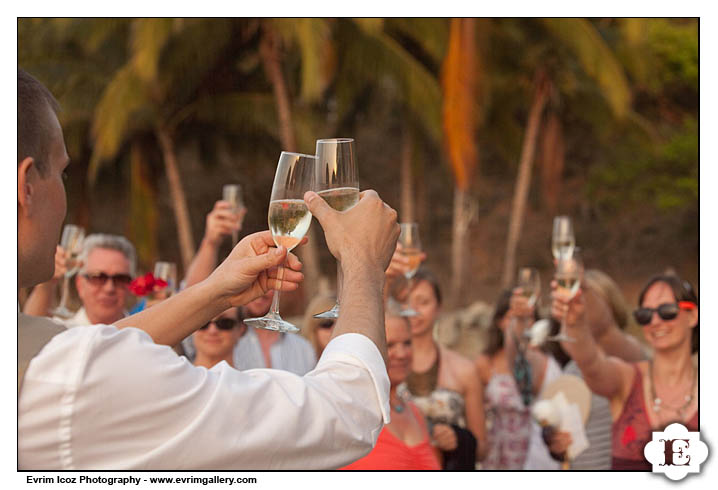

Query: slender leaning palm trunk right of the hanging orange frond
[[501, 74, 549, 288]]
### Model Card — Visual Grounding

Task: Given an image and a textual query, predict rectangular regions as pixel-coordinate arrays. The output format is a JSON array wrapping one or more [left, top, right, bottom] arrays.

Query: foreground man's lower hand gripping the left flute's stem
[[207, 231, 307, 306]]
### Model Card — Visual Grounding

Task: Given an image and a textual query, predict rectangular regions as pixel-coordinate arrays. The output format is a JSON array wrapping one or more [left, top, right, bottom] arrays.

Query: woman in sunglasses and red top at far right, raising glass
[[551, 275, 698, 471]]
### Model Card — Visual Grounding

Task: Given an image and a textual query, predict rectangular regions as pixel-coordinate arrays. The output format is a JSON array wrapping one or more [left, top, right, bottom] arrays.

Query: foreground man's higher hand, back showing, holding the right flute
[[304, 190, 399, 276]]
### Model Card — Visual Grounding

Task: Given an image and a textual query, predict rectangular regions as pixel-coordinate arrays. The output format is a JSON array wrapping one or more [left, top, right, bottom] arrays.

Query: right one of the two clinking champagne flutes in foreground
[[314, 138, 359, 318]]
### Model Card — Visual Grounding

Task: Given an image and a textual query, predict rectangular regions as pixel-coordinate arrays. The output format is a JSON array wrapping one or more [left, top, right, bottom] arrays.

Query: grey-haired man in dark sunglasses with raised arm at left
[[23, 233, 137, 328]]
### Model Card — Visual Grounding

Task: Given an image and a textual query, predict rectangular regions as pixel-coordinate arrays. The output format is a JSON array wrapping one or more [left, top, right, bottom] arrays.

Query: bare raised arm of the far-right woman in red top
[[551, 284, 634, 400]]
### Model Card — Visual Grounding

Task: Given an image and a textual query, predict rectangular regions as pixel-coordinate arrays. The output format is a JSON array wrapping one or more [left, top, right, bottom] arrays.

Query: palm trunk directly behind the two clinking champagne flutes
[[259, 25, 322, 303]]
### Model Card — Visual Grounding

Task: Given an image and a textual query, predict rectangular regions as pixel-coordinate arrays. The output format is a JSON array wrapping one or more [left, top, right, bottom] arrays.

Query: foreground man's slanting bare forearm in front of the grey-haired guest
[[115, 281, 231, 346]]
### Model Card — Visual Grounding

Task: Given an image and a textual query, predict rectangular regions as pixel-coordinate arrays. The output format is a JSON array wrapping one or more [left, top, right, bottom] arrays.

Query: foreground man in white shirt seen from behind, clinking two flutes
[[17, 70, 399, 470]]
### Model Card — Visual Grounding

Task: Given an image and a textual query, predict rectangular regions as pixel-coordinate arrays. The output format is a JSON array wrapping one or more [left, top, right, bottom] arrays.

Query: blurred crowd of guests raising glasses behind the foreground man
[[24, 188, 698, 470]]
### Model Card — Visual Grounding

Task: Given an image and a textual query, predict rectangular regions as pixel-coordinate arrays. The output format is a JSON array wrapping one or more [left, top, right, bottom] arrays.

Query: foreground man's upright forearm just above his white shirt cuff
[[332, 267, 387, 362]]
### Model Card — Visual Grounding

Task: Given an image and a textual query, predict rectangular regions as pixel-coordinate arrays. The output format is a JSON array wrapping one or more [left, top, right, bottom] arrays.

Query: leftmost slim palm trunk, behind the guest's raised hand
[[156, 127, 195, 270]]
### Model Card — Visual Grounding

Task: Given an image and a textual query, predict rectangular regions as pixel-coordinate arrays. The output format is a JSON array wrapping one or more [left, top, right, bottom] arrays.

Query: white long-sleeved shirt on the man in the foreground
[[18, 325, 389, 470]]
